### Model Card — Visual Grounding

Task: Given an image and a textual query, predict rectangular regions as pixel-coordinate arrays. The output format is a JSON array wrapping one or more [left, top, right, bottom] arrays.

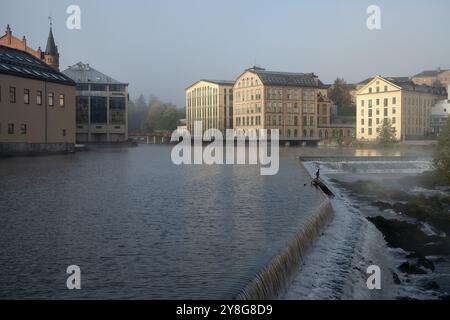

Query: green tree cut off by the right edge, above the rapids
[[433, 118, 450, 185]]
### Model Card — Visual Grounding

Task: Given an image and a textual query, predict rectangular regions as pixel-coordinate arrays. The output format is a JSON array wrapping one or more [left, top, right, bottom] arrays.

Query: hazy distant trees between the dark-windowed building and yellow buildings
[[128, 95, 186, 132]]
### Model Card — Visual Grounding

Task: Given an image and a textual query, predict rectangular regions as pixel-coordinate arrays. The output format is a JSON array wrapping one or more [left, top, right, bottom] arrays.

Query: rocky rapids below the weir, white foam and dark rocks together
[[285, 159, 450, 299]]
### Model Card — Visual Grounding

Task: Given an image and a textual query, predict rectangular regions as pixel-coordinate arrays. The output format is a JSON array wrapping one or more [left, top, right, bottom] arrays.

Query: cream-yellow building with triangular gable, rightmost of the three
[[356, 76, 443, 140]]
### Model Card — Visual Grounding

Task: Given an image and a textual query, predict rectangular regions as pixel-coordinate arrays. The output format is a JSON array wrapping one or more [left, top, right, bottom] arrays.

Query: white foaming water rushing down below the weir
[[283, 161, 433, 299]]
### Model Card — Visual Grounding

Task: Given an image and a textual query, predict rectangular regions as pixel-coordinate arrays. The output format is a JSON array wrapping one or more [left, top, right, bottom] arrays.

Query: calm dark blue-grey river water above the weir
[[0, 146, 323, 299]]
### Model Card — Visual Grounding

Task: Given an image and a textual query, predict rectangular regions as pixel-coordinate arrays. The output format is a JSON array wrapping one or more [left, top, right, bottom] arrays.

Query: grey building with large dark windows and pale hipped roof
[[63, 62, 128, 142]]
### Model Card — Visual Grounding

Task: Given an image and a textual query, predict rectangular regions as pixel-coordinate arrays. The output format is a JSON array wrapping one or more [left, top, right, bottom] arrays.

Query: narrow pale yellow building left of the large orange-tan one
[[186, 80, 234, 134]]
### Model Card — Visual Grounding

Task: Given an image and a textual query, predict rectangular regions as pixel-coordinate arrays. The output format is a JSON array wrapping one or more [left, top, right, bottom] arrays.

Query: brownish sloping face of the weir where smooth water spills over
[[236, 199, 334, 300]]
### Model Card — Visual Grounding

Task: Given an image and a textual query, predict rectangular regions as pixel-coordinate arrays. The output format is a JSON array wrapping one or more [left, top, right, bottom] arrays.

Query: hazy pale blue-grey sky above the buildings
[[0, 0, 450, 107]]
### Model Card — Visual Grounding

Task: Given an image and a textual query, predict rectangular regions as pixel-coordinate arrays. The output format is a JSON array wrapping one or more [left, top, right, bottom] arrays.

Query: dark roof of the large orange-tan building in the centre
[[247, 67, 325, 88]]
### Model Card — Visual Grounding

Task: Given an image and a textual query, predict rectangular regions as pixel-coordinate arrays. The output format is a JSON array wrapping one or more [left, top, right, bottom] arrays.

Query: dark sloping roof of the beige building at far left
[[0, 45, 75, 86]]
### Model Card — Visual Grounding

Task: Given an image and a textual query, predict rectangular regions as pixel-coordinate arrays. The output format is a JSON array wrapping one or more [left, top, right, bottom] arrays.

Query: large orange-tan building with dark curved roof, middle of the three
[[233, 67, 330, 141]]
